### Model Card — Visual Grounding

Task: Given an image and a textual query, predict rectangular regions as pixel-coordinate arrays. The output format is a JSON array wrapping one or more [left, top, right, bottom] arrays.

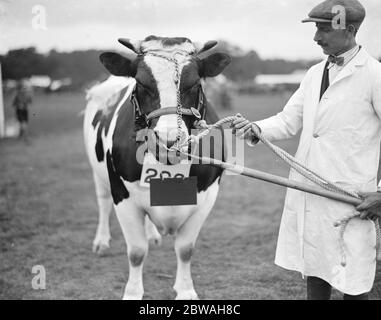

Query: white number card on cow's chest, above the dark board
[[140, 152, 191, 188]]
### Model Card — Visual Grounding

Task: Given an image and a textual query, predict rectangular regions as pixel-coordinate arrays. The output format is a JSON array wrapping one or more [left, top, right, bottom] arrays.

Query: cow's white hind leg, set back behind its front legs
[[93, 173, 112, 255]]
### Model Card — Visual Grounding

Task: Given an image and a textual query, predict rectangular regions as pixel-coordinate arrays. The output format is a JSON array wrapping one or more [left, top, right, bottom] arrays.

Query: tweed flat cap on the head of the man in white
[[302, 0, 365, 24]]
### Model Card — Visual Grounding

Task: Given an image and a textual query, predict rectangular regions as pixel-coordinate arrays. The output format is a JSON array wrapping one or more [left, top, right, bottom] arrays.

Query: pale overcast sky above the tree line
[[0, 0, 381, 59]]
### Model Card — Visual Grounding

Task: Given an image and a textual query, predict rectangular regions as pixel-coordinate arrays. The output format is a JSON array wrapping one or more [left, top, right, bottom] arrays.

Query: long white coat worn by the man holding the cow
[[256, 48, 381, 295]]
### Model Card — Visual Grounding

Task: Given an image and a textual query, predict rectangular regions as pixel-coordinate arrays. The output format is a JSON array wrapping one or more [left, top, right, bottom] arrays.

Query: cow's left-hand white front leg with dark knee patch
[[115, 199, 148, 300]]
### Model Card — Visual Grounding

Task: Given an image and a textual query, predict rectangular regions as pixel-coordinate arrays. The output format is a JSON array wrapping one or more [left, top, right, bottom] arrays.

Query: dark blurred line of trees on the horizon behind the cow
[[0, 41, 326, 88]]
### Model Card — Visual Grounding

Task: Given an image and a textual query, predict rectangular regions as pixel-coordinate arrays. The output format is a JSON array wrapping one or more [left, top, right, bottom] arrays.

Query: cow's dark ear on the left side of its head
[[99, 52, 136, 77]]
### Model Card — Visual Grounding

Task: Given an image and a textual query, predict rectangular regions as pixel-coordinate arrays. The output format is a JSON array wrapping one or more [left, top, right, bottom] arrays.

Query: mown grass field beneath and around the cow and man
[[0, 89, 381, 299]]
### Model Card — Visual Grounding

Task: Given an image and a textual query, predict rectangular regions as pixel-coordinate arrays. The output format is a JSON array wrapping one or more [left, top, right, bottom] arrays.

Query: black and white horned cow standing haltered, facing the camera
[[84, 36, 231, 300]]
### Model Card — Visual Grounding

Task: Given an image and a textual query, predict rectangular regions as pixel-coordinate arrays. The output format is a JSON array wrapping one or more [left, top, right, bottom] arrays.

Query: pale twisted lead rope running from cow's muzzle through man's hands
[[171, 115, 381, 267]]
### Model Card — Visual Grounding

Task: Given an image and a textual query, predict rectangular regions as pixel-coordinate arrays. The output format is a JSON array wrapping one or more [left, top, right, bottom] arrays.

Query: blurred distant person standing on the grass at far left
[[13, 80, 32, 140]]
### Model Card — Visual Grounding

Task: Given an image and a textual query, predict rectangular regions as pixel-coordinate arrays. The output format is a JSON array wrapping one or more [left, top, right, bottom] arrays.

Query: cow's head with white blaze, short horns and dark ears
[[100, 36, 231, 164]]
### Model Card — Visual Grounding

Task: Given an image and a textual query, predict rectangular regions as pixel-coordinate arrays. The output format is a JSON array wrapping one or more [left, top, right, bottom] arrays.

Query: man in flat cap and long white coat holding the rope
[[233, 0, 381, 300]]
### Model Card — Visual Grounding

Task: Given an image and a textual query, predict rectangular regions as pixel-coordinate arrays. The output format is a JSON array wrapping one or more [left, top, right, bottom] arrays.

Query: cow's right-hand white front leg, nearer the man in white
[[173, 182, 218, 300]]
